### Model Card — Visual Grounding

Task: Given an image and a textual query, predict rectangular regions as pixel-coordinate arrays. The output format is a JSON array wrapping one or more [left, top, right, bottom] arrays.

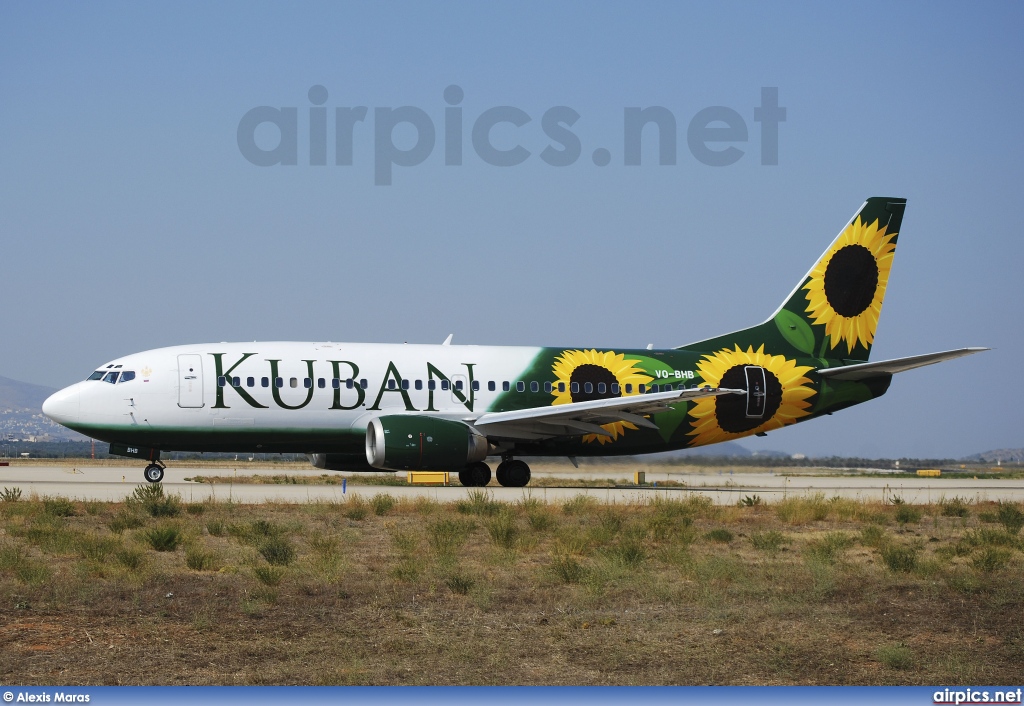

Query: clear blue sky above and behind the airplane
[[0, 2, 1024, 456]]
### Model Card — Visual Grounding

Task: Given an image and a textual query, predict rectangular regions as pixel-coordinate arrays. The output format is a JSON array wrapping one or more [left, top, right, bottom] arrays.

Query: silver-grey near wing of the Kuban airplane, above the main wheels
[[465, 387, 746, 440]]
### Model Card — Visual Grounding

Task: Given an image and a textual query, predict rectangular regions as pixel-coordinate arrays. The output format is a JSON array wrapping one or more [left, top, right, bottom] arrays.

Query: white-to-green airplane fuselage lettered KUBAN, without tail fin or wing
[[43, 342, 889, 460]]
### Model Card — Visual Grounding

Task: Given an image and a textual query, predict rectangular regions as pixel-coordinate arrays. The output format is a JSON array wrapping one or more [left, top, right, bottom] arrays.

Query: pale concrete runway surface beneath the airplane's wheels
[[0, 464, 1024, 505]]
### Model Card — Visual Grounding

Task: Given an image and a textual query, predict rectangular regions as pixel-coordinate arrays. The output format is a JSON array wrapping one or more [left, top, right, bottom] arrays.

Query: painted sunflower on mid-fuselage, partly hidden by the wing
[[551, 348, 654, 444]]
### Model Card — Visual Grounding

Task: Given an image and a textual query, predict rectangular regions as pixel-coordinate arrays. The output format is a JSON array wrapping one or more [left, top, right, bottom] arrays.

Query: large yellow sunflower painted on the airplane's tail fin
[[803, 215, 898, 354]]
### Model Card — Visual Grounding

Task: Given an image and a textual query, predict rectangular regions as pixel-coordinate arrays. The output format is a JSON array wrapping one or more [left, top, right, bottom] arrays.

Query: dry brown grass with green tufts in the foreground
[[0, 491, 1024, 684]]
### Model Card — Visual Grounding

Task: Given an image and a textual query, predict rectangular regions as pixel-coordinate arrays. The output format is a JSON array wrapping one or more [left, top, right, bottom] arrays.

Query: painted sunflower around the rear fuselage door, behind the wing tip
[[687, 345, 814, 446]]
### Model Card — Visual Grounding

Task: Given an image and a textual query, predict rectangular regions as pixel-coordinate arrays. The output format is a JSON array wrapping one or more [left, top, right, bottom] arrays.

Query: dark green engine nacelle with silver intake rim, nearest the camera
[[367, 414, 489, 471]]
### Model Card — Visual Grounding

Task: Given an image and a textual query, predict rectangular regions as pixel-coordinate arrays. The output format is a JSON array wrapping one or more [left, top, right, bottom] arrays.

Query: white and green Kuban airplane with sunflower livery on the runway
[[42, 197, 987, 487]]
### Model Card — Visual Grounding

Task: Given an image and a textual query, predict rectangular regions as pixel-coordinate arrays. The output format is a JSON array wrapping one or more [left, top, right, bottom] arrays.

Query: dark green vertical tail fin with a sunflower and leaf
[[682, 197, 906, 362]]
